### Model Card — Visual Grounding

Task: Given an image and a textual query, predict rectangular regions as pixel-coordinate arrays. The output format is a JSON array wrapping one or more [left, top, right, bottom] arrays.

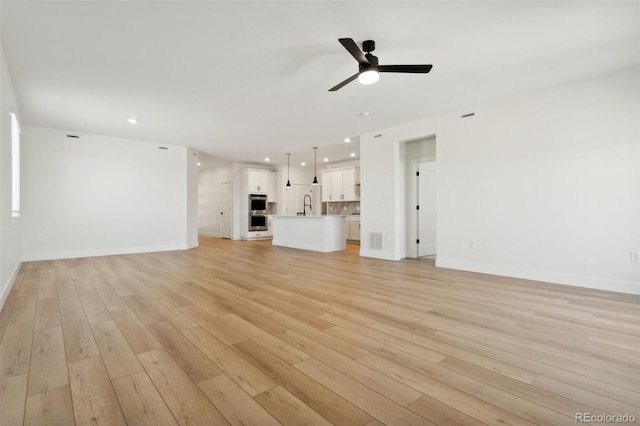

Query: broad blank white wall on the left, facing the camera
[[23, 126, 197, 260]]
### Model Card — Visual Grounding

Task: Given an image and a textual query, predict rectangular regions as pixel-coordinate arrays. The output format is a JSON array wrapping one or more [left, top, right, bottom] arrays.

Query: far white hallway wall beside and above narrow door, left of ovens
[[198, 163, 233, 238]]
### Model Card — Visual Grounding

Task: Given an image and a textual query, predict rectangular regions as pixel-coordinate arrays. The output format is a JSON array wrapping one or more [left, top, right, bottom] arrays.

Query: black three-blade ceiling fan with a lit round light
[[329, 38, 432, 92]]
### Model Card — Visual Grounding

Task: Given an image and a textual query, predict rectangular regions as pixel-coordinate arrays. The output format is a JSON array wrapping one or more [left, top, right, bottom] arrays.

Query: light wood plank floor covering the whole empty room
[[0, 238, 640, 426]]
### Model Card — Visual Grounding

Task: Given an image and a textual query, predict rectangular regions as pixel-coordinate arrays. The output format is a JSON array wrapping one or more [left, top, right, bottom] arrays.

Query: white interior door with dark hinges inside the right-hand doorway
[[417, 161, 437, 256]]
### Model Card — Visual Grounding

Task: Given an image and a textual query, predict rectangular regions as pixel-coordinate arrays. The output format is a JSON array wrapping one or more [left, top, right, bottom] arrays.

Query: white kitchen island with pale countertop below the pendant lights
[[272, 215, 347, 253]]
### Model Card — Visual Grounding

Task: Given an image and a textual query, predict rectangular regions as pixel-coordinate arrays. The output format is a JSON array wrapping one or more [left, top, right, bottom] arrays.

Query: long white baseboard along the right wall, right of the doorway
[[436, 257, 640, 295]]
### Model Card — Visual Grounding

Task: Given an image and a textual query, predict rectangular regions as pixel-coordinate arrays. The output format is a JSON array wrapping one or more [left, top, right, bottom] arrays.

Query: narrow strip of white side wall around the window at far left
[[0, 46, 22, 309]]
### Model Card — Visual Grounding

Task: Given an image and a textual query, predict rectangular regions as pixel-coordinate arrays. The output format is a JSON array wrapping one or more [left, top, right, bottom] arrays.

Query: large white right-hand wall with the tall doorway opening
[[360, 68, 640, 294]]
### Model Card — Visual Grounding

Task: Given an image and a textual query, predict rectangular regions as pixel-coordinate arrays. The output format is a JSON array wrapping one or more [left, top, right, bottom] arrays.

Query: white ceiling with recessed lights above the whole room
[[0, 0, 639, 164]]
